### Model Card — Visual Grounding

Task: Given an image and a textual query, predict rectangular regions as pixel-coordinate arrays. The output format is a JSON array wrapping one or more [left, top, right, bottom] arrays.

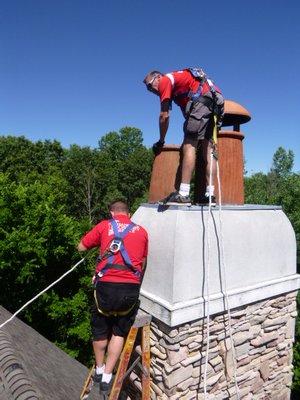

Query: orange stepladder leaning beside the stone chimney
[[80, 310, 151, 400]]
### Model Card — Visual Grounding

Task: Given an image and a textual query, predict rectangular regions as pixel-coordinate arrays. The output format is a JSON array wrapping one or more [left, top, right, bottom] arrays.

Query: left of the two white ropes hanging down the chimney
[[204, 149, 213, 399]]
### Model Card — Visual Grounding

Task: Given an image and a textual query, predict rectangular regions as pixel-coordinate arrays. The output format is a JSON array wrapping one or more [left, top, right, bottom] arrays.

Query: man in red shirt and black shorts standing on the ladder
[[78, 201, 148, 393]]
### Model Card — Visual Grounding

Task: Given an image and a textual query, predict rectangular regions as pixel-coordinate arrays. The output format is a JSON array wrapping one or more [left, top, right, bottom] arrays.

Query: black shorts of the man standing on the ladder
[[91, 282, 140, 340]]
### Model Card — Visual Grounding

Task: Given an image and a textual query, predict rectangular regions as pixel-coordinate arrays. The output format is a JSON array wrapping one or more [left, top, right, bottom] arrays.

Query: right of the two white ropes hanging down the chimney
[[216, 159, 240, 400]]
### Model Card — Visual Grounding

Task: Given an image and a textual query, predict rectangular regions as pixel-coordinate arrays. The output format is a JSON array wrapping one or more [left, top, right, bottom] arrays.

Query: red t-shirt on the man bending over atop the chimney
[[158, 70, 214, 110]]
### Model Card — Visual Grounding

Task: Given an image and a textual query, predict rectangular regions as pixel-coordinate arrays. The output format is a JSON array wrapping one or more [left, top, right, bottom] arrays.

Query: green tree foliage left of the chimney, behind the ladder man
[[0, 127, 152, 363]]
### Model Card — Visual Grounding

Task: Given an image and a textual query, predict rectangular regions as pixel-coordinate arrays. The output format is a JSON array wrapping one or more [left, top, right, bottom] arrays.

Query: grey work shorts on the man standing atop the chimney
[[183, 92, 224, 147]]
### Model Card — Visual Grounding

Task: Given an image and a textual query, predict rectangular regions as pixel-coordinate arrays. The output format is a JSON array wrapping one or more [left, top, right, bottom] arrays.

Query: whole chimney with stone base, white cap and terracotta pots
[[132, 101, 300, 400]]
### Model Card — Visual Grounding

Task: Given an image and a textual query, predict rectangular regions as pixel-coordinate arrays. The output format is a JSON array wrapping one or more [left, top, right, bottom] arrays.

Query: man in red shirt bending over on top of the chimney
[[144, 68, 224, 205]]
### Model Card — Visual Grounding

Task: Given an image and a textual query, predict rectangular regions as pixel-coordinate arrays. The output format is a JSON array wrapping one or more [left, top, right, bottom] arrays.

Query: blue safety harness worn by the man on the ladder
[[93, 219, 142, 316]]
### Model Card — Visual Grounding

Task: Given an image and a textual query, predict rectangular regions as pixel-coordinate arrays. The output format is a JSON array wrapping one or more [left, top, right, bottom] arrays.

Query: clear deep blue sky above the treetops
[[0, 0, 300, 173]]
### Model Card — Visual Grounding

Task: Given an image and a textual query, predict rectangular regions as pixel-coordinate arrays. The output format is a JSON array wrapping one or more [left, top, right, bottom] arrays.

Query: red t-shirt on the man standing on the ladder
[[81, 214, 148, 283]]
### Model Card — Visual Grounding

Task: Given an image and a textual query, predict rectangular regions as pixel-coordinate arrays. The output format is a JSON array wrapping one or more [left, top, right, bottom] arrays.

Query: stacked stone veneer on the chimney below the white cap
[[125, 292, 297, 400]]
